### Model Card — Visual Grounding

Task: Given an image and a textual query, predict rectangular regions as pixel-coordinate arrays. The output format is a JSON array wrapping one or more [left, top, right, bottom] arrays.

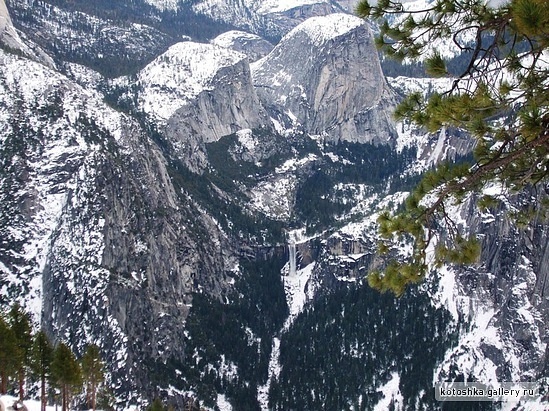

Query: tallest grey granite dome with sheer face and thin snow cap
[[252, 14, 396, 143]]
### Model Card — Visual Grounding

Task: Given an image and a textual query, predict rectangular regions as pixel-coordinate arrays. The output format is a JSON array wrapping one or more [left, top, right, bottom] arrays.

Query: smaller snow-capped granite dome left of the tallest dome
[[137, 42, 268, 172]]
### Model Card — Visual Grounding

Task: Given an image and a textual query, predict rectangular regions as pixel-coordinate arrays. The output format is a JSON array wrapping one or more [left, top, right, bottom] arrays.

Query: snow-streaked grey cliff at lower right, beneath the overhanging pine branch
[[435, 190, 549, 381]]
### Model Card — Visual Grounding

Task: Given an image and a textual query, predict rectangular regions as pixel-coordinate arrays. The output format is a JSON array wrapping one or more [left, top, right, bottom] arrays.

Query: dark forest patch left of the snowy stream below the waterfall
[[171, 259, 288, 410]]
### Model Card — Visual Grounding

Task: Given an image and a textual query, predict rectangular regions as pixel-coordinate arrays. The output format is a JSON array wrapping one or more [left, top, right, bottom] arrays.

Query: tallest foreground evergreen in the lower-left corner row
[[8, 303, 32, 401]]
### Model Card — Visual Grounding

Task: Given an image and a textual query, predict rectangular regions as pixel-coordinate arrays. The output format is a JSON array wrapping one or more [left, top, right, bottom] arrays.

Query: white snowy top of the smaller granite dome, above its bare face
[[138, 42, 246, 121]]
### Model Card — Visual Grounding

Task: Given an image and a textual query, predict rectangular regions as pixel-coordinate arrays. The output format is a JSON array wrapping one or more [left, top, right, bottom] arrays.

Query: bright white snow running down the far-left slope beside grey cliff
[[0, 48, 130, 320]]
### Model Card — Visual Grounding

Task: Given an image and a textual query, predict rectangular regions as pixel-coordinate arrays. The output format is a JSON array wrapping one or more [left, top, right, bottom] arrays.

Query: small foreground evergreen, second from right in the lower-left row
[[51, 343, 82, 411]]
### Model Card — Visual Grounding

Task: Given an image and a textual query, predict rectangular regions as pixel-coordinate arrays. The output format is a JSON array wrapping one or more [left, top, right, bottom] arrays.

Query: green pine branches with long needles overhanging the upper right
[[356, 0, 549, 294]]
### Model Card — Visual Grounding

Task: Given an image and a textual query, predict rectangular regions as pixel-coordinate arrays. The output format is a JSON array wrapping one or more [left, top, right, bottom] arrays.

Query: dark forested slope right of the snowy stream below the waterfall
[[270, 285, 456, 411]]
